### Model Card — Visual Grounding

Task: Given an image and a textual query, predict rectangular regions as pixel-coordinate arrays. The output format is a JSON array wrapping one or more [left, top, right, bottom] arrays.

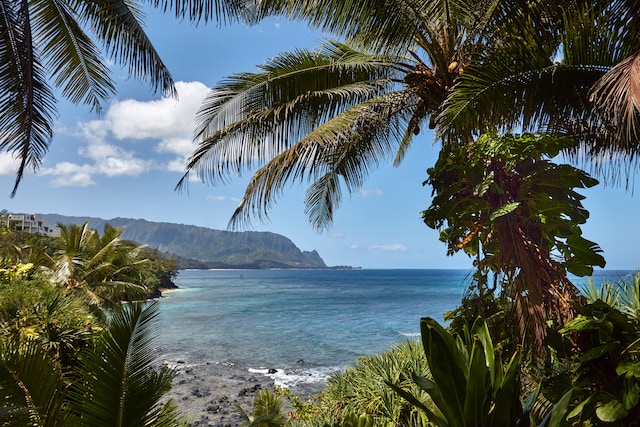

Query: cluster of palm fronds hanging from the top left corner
[[0, 0, 248, 195]]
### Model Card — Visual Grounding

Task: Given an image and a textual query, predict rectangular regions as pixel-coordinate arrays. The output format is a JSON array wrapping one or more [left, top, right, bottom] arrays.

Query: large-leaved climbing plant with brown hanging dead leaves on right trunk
[[422, 133, 605, 353]]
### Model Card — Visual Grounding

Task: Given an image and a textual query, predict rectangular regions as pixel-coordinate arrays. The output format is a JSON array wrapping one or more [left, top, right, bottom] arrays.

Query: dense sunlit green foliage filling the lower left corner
[[0, 224, 179, 426]]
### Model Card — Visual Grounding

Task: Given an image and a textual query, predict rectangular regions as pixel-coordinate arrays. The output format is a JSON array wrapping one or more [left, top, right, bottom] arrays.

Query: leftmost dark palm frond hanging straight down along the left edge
[[0, 0, 55, 197]]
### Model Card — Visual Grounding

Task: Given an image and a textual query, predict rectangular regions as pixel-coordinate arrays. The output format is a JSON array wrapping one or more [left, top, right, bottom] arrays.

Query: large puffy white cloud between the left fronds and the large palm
[[45, 82, 208, 186]]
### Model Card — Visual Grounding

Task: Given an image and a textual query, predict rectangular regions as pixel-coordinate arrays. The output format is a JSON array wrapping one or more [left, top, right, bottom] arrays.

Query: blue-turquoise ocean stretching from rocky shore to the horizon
[[158, 269, 631, 392]]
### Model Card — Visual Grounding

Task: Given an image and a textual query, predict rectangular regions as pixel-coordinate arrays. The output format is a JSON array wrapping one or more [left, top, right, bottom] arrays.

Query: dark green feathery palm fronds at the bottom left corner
[[0, 304, 180, 427]]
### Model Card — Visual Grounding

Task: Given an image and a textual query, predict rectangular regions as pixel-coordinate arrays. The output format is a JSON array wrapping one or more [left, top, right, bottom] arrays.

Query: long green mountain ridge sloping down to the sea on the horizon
[[42, 214, 327, 268]]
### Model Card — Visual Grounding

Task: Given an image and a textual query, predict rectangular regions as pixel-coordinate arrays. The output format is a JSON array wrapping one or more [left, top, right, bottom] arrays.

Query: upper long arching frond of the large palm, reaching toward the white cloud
[[177, 42, 397, 189]]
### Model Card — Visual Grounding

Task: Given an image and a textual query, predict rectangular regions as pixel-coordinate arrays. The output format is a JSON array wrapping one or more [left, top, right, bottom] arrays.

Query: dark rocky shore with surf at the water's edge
[[167, 362, 322, 427]]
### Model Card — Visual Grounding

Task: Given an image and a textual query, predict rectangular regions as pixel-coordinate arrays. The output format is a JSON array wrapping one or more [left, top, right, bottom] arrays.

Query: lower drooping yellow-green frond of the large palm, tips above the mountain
[[229, 92, 407, 230]]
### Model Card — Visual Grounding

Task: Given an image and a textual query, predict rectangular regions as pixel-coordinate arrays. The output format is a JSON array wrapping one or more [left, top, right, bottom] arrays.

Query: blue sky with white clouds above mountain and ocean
[[0, 10, 640, 269]]
